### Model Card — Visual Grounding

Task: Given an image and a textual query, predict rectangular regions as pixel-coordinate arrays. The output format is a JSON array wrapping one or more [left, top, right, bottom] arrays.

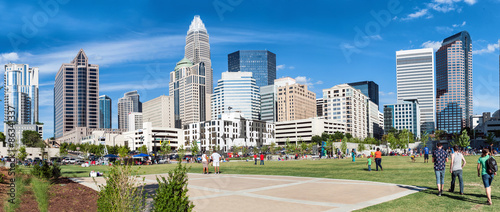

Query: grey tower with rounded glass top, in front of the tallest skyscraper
[[168, 58, 207, 128]]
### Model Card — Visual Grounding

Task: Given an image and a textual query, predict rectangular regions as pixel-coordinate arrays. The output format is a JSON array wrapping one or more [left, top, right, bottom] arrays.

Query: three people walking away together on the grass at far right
[[432, 143, 497, 205]]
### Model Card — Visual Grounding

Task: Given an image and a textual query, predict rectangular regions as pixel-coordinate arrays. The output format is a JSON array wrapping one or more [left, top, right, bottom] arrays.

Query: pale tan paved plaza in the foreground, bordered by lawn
[[72, 174, 425, 212]]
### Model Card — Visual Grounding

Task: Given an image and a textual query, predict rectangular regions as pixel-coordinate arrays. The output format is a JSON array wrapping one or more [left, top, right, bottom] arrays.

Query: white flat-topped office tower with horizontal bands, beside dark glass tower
[[396, 48, 436, 133]]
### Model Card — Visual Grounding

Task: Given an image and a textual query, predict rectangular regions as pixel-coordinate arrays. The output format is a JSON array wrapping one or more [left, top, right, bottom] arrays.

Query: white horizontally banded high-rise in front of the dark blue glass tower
[[212, 72, 260, 120]]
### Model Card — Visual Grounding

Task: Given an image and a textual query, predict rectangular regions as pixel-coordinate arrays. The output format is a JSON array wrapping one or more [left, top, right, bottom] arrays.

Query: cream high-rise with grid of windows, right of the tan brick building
[[323, 84, 368, 138]]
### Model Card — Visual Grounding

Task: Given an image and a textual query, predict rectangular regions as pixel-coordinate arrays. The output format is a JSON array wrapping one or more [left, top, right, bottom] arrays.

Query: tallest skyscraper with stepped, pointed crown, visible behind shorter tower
[[184, 15, 213, 94]]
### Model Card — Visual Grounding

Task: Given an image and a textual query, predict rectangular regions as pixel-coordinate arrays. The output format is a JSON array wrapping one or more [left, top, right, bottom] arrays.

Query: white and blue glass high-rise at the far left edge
[[4, 63, 38, 126]]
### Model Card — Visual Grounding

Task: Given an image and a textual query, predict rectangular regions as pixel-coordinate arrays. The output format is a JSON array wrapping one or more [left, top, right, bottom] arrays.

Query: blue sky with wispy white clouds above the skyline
[[0, 0, 500, 138]]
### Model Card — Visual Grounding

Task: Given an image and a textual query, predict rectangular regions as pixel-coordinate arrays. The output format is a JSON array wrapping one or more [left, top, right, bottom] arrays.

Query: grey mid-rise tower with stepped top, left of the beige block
[[118, 91, 142, 130]]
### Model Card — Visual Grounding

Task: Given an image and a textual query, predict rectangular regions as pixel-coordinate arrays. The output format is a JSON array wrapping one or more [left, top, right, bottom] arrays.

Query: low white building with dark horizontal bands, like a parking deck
[[276, 117, 346, 146]]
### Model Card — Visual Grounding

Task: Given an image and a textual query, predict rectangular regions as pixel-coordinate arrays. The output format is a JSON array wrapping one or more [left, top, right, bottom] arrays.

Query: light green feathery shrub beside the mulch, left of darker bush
[[94, 165, 146, 212]]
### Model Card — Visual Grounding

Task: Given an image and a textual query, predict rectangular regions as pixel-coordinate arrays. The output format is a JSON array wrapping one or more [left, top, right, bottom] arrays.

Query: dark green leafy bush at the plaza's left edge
[[153, 160, 194, 211]]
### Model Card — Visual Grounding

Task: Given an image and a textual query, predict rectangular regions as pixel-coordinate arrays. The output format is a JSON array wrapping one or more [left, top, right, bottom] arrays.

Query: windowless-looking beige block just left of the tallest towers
[[142, 95, 175, 128]]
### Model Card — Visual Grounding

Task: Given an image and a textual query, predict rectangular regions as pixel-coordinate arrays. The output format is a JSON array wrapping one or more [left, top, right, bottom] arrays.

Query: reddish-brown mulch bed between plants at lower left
[[0, 167, 98, 212]]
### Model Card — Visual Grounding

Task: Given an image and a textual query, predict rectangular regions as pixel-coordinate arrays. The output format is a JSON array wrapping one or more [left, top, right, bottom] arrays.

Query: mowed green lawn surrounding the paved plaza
[[38, 156, 500, 211]]
